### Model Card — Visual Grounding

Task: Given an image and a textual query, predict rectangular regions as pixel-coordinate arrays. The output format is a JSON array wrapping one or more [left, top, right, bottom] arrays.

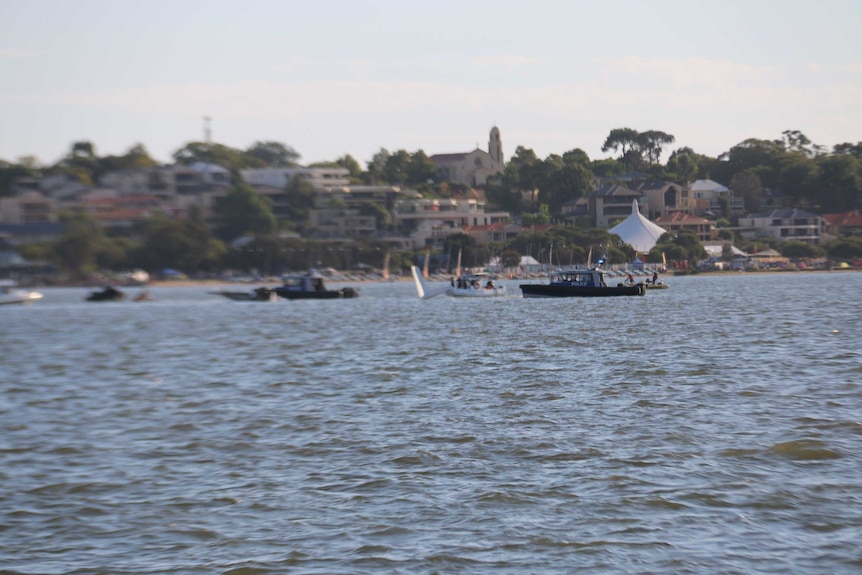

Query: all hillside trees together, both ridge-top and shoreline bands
[[0, 128, 862, 274]]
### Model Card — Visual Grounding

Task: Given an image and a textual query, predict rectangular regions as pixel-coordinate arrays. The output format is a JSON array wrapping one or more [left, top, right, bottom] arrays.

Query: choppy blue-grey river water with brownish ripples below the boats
[[0, 273, 862, 575]]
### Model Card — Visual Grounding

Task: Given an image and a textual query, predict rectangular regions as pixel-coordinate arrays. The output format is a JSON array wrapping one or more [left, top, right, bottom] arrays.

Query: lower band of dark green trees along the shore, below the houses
[[20, 210, 862, 280]]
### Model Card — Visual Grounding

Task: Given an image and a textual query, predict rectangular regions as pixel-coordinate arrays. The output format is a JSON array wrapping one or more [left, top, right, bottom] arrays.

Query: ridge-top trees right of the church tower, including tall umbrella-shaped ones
[[486, 128, 862, 218]]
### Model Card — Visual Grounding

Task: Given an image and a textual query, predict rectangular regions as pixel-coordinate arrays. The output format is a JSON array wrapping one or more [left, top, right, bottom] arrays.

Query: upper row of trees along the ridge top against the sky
[[0, 128, 862, 216]]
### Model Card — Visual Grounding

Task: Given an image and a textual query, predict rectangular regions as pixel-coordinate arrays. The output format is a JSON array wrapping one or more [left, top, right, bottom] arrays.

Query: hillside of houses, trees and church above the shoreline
[[0, 127, 862, 277]]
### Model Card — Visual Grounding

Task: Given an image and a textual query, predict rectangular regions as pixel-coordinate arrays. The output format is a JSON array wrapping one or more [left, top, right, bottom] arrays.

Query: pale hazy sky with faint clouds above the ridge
[[0, 0, 862, 169]]
